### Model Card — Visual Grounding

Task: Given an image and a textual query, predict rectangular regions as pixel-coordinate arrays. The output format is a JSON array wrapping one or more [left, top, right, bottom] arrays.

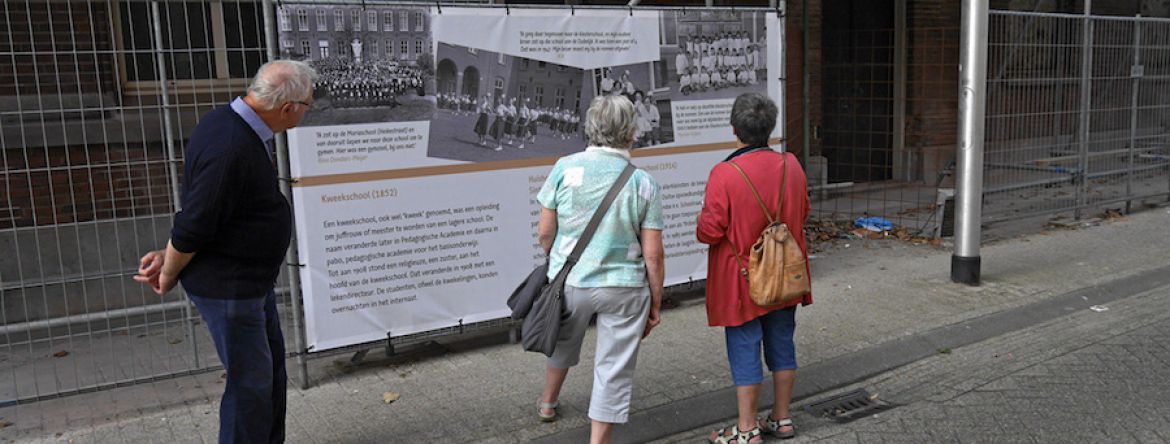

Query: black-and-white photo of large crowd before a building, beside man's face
[[278, 5, 435, 127]]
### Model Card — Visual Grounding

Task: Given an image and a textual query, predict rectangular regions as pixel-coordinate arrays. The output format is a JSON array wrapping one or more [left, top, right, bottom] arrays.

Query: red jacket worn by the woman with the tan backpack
[[696, 150, 812, 327]]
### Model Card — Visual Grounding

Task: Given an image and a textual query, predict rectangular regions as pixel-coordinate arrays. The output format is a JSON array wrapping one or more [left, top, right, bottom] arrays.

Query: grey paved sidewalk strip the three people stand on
[[0, 209, 1170, 443]]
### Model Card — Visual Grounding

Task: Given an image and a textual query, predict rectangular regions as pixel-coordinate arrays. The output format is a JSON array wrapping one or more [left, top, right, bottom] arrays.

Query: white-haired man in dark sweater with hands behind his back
[[135, 60, 317, 443]]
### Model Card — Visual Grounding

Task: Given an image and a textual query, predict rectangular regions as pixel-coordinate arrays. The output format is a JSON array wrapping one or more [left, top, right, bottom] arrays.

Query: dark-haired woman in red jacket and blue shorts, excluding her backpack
[[696, 94, 812, 443]]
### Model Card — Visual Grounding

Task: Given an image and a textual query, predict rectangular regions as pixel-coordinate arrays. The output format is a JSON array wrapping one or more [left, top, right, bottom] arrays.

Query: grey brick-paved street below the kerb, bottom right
[[659, 261, 1170, 444]]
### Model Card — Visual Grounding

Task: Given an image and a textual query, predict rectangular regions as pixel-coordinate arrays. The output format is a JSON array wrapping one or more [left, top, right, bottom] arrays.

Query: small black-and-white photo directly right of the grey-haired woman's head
[[590, 62, 674, 148]]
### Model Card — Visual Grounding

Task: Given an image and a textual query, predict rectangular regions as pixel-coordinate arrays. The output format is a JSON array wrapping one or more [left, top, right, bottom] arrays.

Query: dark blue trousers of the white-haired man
[[187, 291, 288, 444]]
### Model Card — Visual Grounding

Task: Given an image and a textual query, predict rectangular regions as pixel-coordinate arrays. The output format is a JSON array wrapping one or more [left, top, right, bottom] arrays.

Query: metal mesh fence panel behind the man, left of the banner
[[0, 0, 266, 405]]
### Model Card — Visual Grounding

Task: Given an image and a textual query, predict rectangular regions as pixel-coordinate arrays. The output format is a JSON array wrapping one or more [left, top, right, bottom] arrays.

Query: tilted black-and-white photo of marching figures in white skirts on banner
[[427, 42, 593, 162]]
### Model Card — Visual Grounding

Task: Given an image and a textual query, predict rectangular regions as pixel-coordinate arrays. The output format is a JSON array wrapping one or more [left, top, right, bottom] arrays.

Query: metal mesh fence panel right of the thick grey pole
[[984, 11, 1170, 221]]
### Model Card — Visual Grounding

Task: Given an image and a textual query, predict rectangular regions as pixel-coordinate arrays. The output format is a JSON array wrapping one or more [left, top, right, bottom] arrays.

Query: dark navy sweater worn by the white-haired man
[[171, 107, 293, 299]]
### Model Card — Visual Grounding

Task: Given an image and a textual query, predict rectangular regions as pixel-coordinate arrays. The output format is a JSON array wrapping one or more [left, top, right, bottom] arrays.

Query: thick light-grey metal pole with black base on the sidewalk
[[951, 0, 987, 286]]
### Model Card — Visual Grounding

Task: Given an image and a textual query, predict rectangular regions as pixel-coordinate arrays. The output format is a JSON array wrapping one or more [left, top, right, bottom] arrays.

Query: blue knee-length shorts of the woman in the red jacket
[[723, 307, 797, 385]]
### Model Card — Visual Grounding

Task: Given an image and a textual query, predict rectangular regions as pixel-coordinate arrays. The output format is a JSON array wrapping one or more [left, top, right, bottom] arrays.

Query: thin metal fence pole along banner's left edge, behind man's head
[[262, 0, 309, 390]]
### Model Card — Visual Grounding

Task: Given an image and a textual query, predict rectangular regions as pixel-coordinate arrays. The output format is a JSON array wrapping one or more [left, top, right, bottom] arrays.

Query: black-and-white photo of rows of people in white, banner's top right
[[658, 11, 768, 101]]
